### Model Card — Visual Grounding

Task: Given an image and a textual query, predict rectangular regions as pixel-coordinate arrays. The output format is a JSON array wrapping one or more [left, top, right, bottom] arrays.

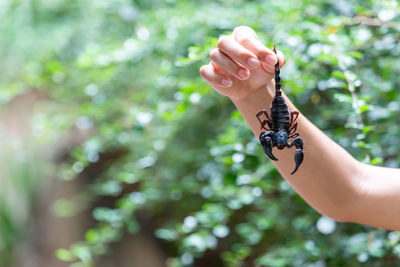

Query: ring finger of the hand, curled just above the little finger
[[210, 48, 250, 80]]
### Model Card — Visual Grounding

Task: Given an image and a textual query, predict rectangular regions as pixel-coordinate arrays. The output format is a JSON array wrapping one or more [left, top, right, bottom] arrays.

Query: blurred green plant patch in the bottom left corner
[[0, 143, 48, 266]]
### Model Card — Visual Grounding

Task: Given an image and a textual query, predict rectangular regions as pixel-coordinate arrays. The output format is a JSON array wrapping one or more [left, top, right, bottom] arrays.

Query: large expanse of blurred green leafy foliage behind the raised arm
[[0, 0, 400, 266]]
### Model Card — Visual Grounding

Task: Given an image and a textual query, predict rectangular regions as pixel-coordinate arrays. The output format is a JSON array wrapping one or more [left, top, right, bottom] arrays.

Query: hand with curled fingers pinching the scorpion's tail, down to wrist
[[200, 26, 285, 100]]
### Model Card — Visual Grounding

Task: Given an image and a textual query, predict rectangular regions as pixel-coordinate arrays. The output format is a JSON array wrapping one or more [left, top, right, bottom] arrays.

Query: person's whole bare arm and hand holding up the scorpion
[[200, 26, 400, 231]]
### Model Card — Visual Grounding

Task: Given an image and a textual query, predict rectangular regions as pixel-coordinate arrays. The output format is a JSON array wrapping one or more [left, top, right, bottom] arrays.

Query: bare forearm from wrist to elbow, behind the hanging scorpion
[[232, 81, 362, 221]]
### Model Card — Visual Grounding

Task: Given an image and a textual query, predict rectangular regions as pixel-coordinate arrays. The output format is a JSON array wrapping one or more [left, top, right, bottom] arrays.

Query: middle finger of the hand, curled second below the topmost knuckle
[[218, 35, 260, 69]]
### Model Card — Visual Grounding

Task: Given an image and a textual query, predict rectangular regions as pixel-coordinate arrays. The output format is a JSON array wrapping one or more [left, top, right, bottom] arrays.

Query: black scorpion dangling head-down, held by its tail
[[256, 46, 304, 174]]
